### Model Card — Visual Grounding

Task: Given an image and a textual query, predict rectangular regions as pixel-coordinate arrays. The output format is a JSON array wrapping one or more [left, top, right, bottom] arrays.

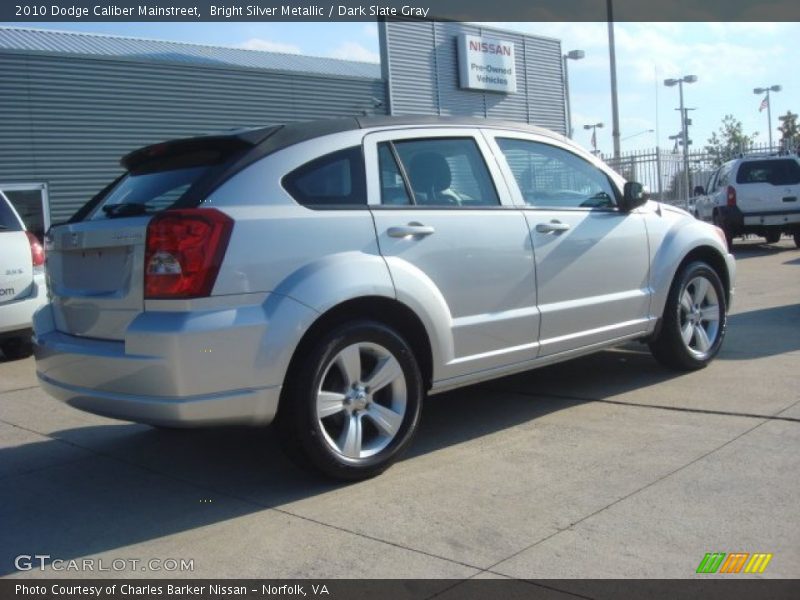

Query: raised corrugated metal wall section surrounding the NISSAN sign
[[385, 21, 566, 133]]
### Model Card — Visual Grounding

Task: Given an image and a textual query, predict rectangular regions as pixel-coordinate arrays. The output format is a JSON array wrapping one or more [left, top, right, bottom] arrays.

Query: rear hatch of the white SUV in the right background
[[736, 157, 800, 214]]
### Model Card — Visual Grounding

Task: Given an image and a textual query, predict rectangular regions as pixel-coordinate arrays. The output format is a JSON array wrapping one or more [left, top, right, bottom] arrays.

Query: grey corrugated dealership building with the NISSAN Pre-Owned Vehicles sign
[[0, 21, 566, 232]]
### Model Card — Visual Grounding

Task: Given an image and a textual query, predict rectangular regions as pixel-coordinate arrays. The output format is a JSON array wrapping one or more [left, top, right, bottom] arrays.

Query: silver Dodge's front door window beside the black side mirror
[[497, 138, 617, 208]]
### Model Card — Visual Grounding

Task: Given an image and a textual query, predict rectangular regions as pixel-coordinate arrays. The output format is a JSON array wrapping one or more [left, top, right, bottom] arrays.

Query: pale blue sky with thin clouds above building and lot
[[8, 22, 800, 154]]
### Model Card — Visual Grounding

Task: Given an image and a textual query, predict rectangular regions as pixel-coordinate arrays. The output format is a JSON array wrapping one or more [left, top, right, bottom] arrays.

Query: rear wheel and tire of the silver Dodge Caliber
[[278, 320, 424, 481]]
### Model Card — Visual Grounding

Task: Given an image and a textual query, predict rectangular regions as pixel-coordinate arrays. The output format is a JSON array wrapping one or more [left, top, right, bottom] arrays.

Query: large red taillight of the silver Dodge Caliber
[[144, 208, 233, 299]]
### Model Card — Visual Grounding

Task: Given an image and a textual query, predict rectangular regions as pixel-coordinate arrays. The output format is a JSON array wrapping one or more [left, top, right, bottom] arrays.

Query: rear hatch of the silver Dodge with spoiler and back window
[[46, 129, 280, 340]]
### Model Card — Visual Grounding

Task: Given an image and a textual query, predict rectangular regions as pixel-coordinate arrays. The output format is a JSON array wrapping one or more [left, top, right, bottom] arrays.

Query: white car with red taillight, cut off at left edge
[[0, 192, 47, 359]]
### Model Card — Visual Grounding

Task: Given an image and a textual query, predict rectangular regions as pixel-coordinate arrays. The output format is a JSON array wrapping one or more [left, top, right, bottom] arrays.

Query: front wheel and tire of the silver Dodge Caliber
[[650, 261, 728, 371]]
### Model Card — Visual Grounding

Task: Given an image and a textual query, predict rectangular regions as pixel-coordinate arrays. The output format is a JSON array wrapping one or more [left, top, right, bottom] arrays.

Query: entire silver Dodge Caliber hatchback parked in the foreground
[[34, 117, 735, 479]]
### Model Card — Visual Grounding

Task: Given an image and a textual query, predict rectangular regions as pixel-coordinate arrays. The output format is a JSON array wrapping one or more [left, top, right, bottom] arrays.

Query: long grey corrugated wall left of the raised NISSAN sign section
[[0, 53, 385, 223]]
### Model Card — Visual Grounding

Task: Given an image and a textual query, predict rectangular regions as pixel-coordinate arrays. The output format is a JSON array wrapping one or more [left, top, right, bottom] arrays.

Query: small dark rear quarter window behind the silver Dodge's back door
[[283, 146, 367, 208]]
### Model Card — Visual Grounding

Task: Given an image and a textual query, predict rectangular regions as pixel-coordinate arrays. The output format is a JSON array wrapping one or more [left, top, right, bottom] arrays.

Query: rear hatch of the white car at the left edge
[[0, 196, 33, 304]]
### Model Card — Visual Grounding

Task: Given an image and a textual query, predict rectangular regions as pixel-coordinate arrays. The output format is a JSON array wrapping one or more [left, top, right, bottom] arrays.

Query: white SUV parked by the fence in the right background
[[696, 155, 800, 248]]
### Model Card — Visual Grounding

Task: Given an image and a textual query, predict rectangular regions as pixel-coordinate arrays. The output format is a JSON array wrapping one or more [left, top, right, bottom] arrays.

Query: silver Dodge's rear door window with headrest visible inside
[[390, 138, 500, 207]]
